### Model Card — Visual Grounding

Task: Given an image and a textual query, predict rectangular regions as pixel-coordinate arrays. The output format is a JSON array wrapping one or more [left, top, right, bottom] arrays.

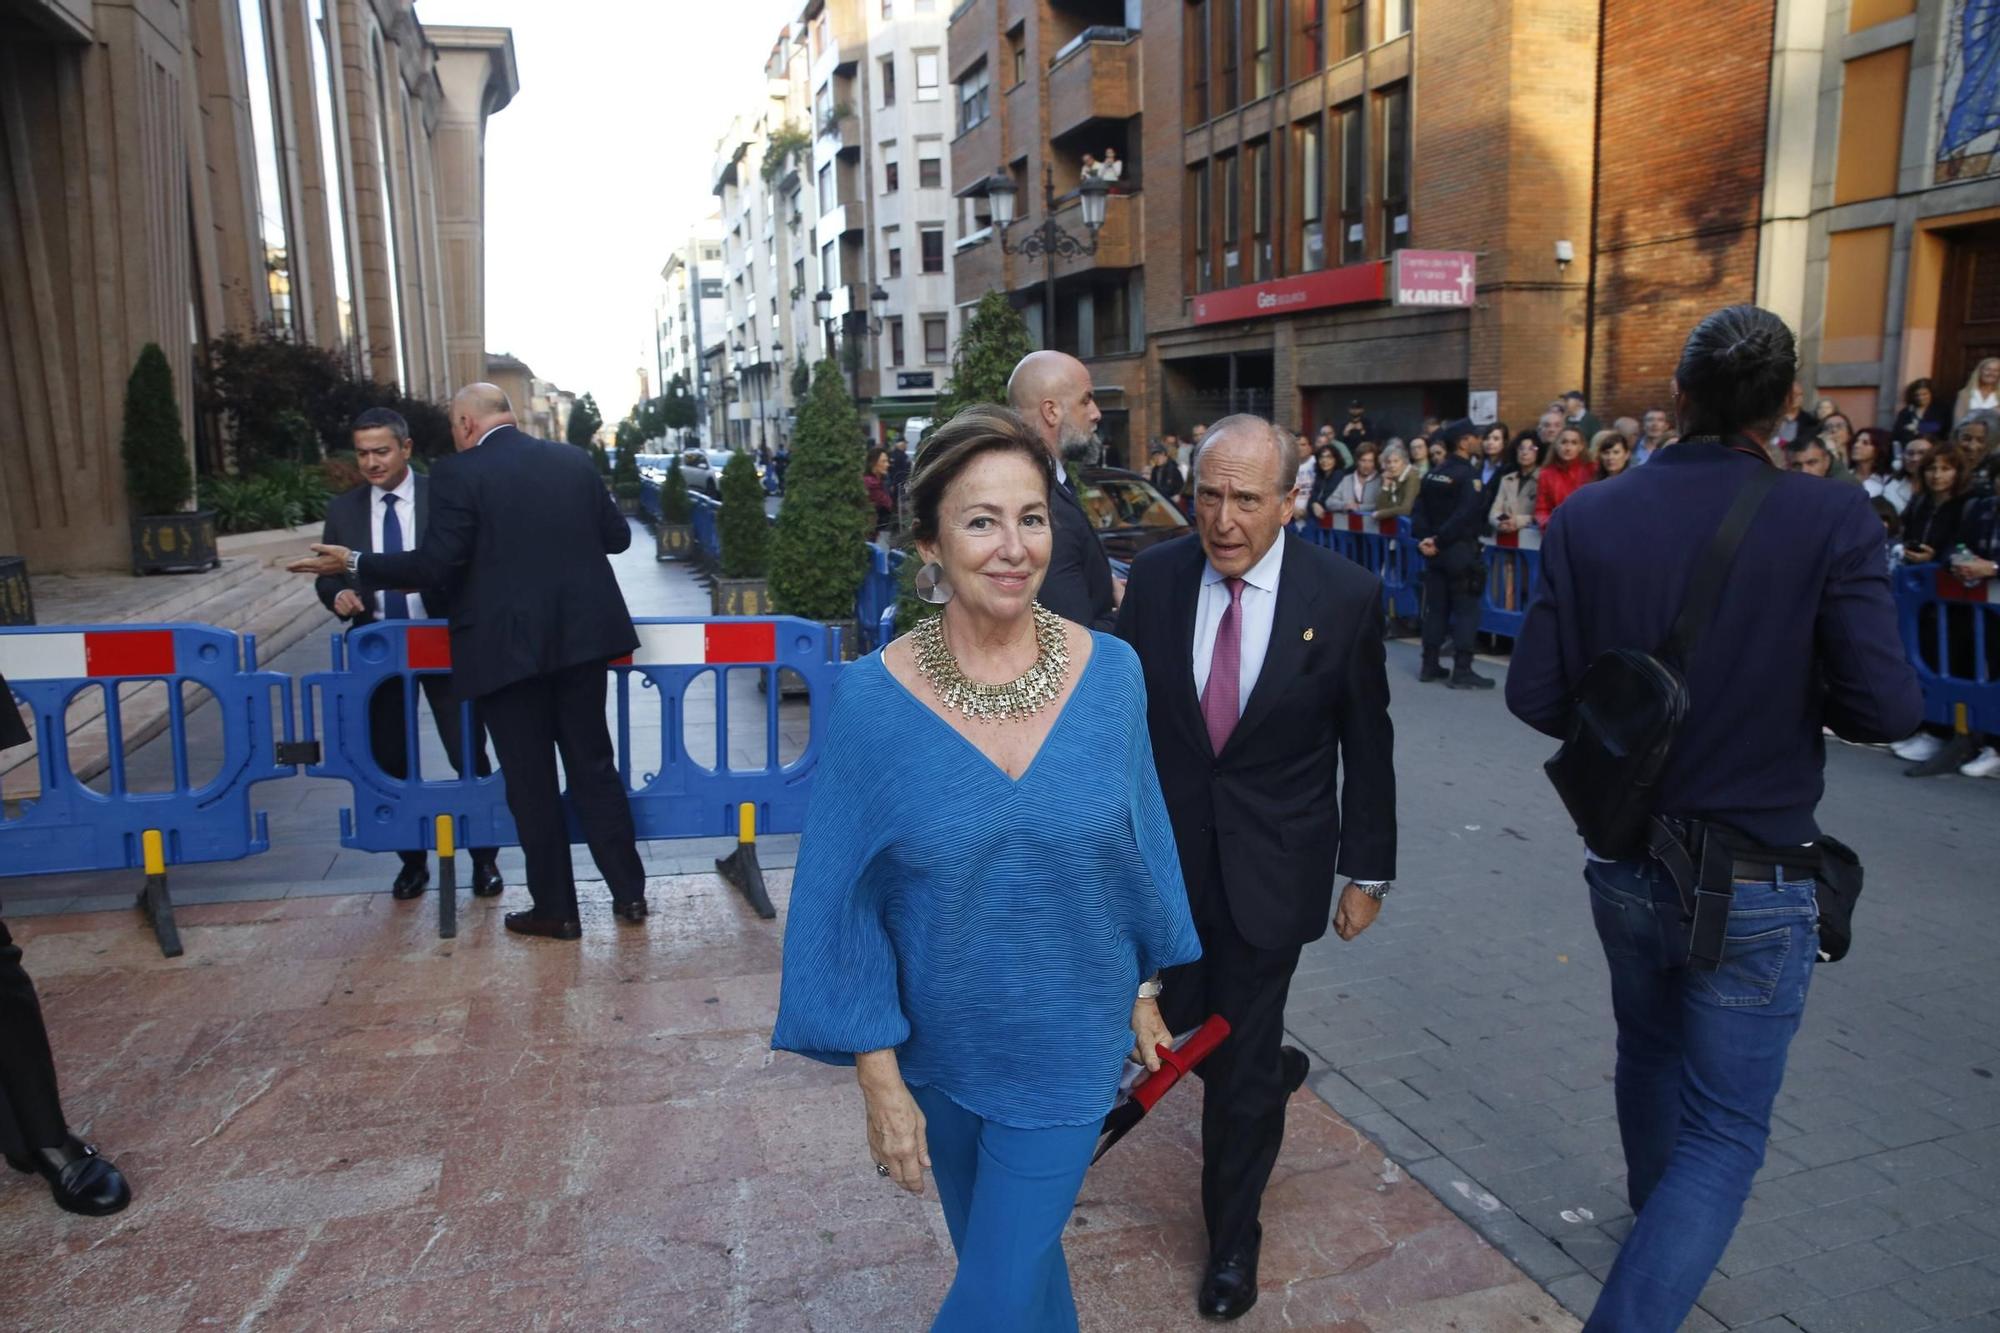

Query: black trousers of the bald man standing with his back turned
[[478, 662, 646, 921]]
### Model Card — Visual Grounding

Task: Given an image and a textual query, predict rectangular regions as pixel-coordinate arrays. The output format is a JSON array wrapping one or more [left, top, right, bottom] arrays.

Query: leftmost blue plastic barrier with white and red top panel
[[0, 624, 298, 957]]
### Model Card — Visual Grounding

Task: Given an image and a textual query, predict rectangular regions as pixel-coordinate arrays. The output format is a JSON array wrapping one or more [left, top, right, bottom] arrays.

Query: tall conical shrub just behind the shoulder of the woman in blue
[[770, 360, 874, 656]]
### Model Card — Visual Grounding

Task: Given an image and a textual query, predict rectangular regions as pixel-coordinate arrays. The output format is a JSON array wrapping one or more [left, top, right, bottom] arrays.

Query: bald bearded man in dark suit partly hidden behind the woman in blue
[[1006, 352, 1120, 630]]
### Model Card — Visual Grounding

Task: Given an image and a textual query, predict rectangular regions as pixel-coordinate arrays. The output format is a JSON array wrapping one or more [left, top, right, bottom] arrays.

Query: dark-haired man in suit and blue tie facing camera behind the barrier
[[314, 408, 506, 899]]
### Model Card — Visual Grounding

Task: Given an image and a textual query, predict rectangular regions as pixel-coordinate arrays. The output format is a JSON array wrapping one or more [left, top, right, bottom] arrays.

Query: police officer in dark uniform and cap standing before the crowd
[[1410, 418, 1494, 691]]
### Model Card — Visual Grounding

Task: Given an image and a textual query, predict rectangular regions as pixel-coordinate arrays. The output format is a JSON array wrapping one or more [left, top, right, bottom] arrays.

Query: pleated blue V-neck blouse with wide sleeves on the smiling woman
[[772, 634, 1202, 1129]]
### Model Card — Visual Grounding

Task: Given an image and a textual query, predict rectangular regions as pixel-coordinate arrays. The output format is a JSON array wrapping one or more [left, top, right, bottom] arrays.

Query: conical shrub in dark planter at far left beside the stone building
[[120, 342, 220, 574]]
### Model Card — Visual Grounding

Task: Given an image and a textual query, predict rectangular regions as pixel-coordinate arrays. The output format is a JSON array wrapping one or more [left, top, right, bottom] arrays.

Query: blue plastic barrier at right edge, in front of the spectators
[[1894, 564, 2000, 735]]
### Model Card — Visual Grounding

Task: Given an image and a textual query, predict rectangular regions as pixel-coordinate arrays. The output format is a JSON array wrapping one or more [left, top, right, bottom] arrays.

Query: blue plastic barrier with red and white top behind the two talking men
[[302, 616, 840, 925]]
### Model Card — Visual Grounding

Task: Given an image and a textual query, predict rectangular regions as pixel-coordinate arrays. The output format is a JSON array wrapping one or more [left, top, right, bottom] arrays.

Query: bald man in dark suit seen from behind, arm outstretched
[[292, 384, 646, 939]]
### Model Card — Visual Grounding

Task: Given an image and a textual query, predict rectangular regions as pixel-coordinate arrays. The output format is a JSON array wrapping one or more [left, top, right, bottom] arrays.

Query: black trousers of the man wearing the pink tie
[[1160, 872, 1298, 1259]]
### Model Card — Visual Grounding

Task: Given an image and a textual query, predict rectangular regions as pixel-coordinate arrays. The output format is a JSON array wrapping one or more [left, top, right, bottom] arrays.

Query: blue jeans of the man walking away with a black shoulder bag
[[1584, 861, 1820, 1333]]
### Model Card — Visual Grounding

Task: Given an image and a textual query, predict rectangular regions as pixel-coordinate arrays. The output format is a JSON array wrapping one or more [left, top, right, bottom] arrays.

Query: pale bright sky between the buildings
[[416, 0, 804, 422]]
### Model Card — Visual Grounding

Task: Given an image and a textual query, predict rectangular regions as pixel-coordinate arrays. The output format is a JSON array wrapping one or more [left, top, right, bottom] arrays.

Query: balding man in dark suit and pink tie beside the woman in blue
[[1118, 416, 1396, 1319]]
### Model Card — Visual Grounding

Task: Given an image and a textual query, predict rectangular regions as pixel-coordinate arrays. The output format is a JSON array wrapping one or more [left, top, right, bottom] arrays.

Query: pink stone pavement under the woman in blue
[[0, 873, 1576, 1333]]
